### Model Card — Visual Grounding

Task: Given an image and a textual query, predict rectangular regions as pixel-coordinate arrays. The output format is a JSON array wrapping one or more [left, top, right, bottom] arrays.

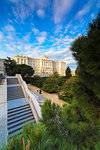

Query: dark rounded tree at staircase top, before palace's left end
[[13, 64, 34, 79]]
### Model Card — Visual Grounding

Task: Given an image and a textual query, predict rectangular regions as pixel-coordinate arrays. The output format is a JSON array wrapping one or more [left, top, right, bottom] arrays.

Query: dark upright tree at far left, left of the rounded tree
[[4, 57, 17, 76]]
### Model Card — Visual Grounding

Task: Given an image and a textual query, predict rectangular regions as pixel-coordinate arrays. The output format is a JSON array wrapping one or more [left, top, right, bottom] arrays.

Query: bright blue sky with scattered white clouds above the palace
[[0, 0, 100, 70]]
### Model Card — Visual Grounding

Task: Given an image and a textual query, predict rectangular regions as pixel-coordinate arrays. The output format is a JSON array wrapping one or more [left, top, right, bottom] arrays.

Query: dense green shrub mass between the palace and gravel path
[[25, 74, 66, 93]]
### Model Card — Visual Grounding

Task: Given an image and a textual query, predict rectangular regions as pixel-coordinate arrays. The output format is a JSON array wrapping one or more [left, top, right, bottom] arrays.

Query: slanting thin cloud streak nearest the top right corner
[[76, 0, 92, 18]]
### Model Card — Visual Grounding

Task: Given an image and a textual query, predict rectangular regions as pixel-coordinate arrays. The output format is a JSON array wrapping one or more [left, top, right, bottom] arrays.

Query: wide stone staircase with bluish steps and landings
[[7, 77, 35, 137]]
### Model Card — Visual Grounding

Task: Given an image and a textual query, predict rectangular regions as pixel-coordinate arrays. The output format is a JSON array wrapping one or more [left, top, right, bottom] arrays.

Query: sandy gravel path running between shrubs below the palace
[[28, 84, 67, 106]]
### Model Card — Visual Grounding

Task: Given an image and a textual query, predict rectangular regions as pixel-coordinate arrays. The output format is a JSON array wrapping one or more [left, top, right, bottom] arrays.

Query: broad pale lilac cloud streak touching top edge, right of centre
[[53, 0, 75, 23]]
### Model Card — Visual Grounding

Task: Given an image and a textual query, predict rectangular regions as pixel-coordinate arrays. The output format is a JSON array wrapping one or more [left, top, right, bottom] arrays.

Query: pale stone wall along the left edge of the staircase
[[0, 79, 8, 148]]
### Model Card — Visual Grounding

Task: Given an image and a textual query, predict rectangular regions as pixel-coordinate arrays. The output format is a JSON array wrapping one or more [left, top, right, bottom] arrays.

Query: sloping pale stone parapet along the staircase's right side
[[16, 74, 41, 122]]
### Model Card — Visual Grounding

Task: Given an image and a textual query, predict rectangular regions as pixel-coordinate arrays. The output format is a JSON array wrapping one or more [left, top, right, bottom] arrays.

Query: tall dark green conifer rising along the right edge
[[71, 14, 100, 122]]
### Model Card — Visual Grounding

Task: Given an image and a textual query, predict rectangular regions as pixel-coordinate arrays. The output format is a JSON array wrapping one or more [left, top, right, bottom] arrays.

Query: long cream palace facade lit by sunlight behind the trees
[[14, 54, 66, 77]]
